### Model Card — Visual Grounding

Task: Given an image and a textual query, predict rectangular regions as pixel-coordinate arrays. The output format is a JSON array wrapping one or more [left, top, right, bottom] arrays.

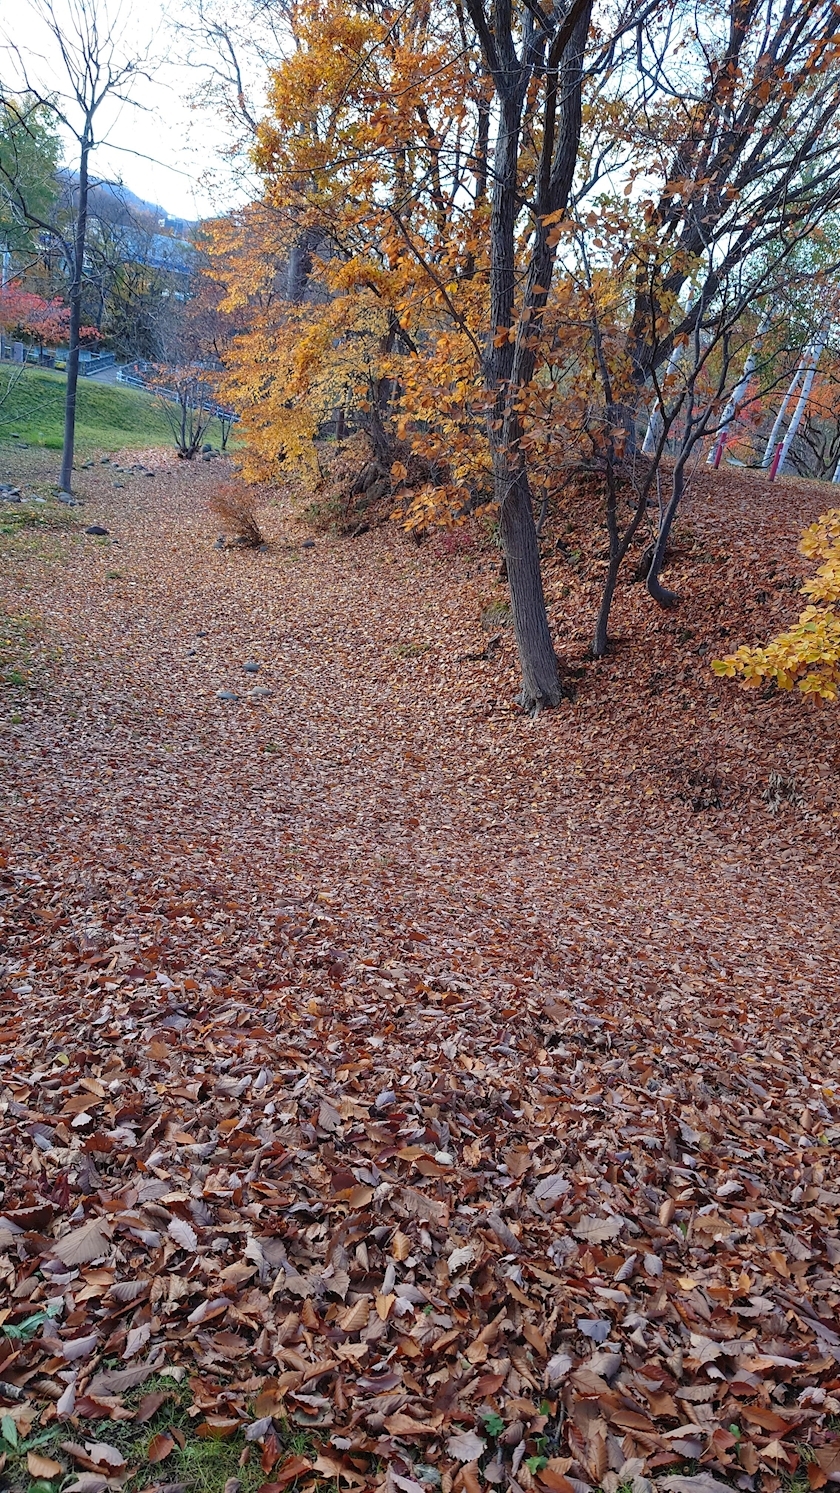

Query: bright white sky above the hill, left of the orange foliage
[[0, 0, 259, 219]]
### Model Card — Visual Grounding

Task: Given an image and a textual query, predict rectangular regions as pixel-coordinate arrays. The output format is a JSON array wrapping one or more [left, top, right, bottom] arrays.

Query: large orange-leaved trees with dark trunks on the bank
[[208, 0, 840, 711]]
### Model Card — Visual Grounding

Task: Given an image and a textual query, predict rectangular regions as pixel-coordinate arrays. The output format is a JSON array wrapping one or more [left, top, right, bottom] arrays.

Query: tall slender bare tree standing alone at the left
[[0, 0, 151, 491]]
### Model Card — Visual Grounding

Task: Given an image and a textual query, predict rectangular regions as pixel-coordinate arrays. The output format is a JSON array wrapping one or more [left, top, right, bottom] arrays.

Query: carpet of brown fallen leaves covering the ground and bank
[[0, 452, 840, 1493]]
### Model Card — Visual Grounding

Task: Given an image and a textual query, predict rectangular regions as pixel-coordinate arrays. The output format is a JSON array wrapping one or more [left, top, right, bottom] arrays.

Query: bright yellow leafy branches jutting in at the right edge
[[712, 508, 840, 700]]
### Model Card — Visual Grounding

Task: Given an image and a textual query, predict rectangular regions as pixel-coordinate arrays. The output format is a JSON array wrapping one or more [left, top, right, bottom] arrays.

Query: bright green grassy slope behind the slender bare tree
[[0, 369, 228, 455]]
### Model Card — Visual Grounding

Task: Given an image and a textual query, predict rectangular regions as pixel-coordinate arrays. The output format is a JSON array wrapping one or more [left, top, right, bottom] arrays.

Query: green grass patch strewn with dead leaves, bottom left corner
[[0, 1375, 319, 1493]]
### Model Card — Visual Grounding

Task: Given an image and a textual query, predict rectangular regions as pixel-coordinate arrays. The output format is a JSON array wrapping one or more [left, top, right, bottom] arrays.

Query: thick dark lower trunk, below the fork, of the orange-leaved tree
[[497, 460, 562, 714]]
